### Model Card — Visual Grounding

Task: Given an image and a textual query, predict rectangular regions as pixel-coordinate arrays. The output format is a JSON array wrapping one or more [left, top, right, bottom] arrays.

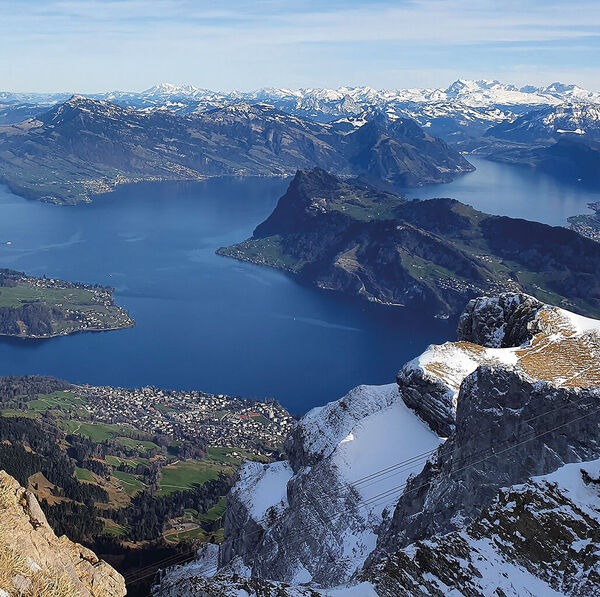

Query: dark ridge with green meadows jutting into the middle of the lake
[[218, 168, 600, 316]]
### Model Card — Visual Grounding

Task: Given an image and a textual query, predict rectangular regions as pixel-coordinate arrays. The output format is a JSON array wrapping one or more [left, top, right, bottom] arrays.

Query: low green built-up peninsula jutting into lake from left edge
[[0, 269, 135, 338]]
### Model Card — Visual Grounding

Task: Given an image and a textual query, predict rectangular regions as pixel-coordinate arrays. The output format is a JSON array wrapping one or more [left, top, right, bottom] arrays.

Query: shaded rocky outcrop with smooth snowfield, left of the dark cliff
[[220, 384, 441, 586]]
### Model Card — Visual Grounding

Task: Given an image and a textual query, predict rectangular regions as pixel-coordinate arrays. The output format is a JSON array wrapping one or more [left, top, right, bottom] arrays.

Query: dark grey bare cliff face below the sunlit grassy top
[[379, 366, 600, 552]]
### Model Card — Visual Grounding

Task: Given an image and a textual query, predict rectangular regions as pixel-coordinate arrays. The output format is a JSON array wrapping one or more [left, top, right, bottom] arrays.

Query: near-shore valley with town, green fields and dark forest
[[0, 377, 293, 585]]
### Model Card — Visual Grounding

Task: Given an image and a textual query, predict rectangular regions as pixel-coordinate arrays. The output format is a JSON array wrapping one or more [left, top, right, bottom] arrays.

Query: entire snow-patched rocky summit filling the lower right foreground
[[155, 294, 600, 597]]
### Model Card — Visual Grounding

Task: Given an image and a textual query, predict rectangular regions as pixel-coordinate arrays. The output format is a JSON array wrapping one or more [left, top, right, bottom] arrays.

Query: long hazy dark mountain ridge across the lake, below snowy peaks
[[0, 96, 473, 203]]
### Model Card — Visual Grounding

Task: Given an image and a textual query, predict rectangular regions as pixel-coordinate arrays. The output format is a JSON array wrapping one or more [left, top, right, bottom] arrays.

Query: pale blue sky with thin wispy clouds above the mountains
[[0, 0, 600, 93]]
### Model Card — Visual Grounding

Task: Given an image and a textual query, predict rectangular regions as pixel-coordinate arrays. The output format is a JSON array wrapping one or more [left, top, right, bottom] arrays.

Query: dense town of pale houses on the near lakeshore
[[78, 386, 295, 456]]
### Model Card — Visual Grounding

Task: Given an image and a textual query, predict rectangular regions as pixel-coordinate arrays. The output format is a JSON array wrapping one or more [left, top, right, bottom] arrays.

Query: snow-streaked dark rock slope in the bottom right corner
[[361, 460, 600, 597]]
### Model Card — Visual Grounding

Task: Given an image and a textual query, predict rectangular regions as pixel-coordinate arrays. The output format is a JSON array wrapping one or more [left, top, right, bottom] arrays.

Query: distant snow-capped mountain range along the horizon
[[0, 79, 600, 133]]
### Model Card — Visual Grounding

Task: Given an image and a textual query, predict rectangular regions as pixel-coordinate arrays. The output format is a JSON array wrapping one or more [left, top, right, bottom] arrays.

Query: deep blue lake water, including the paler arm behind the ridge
[[0, 160, 600, 413]]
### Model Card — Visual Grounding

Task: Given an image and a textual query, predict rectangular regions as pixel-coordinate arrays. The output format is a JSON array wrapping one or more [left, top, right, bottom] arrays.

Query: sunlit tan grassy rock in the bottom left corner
[[0, 471, 127, 597]]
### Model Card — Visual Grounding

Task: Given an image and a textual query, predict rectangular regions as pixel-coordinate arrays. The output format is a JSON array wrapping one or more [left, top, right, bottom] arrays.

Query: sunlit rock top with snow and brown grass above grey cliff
[[397, 293, 600, 436]]
